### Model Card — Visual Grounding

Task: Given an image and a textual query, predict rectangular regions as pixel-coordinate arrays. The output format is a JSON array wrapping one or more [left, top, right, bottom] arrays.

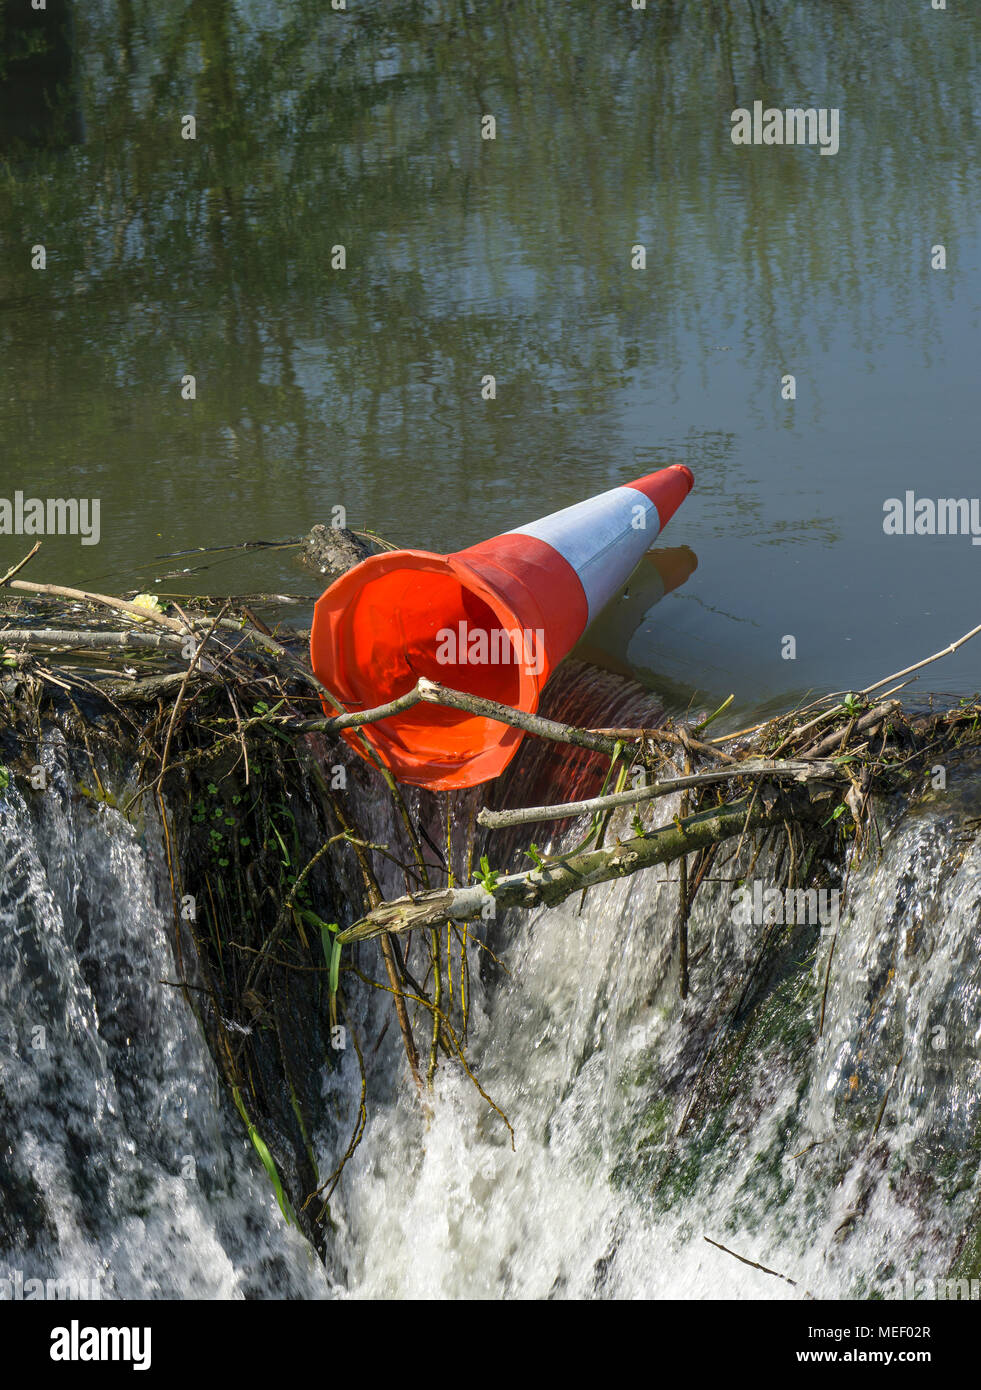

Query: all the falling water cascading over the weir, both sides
[[0, 666, 981, 1298]]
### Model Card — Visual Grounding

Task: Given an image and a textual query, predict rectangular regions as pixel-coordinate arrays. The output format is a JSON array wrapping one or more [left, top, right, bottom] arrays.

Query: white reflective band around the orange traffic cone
[[507, 487, 661, 621]]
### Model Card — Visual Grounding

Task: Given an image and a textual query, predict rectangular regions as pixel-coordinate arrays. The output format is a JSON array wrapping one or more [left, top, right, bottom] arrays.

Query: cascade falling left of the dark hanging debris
[[0, 745, 327, 1298]]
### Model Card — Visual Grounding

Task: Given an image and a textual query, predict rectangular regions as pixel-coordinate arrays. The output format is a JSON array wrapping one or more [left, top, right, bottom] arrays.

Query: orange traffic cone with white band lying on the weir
[[310, 464, 693, 790]]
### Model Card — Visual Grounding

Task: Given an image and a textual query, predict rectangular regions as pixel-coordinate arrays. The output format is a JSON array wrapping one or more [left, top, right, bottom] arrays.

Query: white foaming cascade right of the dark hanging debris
[[326, 789, 981, 1298]]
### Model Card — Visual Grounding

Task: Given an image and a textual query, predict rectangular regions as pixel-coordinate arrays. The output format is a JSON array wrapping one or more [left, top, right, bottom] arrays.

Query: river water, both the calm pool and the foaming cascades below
[[0, 0, 981, 1298]]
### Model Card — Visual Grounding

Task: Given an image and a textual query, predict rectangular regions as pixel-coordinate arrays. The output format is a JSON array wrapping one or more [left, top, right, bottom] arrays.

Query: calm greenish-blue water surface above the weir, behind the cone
[[0, 8, 981, 714]]
